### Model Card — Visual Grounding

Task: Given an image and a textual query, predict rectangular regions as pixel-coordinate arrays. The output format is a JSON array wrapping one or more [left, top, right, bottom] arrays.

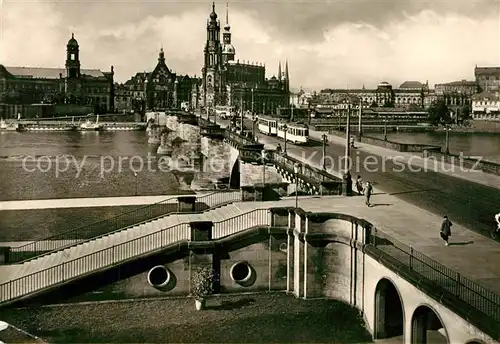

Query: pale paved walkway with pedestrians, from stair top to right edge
[[238, 194, 500, 294]]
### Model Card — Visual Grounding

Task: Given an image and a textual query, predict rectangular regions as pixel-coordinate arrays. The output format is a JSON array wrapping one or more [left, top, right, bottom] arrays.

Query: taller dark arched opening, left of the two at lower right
[[374, 278, 405, 343]]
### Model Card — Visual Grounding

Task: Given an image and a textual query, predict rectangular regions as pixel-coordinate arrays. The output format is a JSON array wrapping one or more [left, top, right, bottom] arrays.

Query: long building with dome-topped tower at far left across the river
[[0, 34, 114, 118]]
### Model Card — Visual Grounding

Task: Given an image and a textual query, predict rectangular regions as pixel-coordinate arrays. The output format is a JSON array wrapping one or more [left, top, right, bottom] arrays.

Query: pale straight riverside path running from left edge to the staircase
[[0, 194, 186, 211]]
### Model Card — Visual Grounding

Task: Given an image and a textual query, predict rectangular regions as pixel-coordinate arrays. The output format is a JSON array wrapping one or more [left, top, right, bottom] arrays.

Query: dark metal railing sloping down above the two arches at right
[[369, 228, 500, 322]]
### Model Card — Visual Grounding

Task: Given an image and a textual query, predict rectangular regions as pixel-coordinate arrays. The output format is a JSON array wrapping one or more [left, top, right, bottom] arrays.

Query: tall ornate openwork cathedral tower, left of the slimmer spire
[[202, 2, 222, 106]]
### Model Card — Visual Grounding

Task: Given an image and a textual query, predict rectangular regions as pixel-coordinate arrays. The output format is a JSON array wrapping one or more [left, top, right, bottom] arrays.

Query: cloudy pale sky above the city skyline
[[0, 0, 500, 91]]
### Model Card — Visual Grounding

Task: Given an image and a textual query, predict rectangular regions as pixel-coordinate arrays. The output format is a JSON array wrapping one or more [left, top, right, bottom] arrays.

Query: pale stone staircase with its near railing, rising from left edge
[[0, 203, 270, 304]]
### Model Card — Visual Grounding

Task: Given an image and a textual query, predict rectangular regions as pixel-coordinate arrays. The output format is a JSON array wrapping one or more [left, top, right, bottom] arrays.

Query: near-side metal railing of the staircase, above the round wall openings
[[0, 209, 270, 304]]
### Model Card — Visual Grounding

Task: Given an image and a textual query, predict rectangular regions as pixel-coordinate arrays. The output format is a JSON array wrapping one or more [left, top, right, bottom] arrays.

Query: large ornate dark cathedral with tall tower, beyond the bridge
[[200, 2, 290, 113]]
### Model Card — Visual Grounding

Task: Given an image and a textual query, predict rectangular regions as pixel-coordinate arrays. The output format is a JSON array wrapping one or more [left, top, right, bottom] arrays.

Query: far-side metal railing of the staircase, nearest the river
[[9, 190, 241, 263]]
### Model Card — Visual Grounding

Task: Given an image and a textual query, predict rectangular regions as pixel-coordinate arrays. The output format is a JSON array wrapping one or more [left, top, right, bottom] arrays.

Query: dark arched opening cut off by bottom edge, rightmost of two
[[411, 306, 448, 344]]
